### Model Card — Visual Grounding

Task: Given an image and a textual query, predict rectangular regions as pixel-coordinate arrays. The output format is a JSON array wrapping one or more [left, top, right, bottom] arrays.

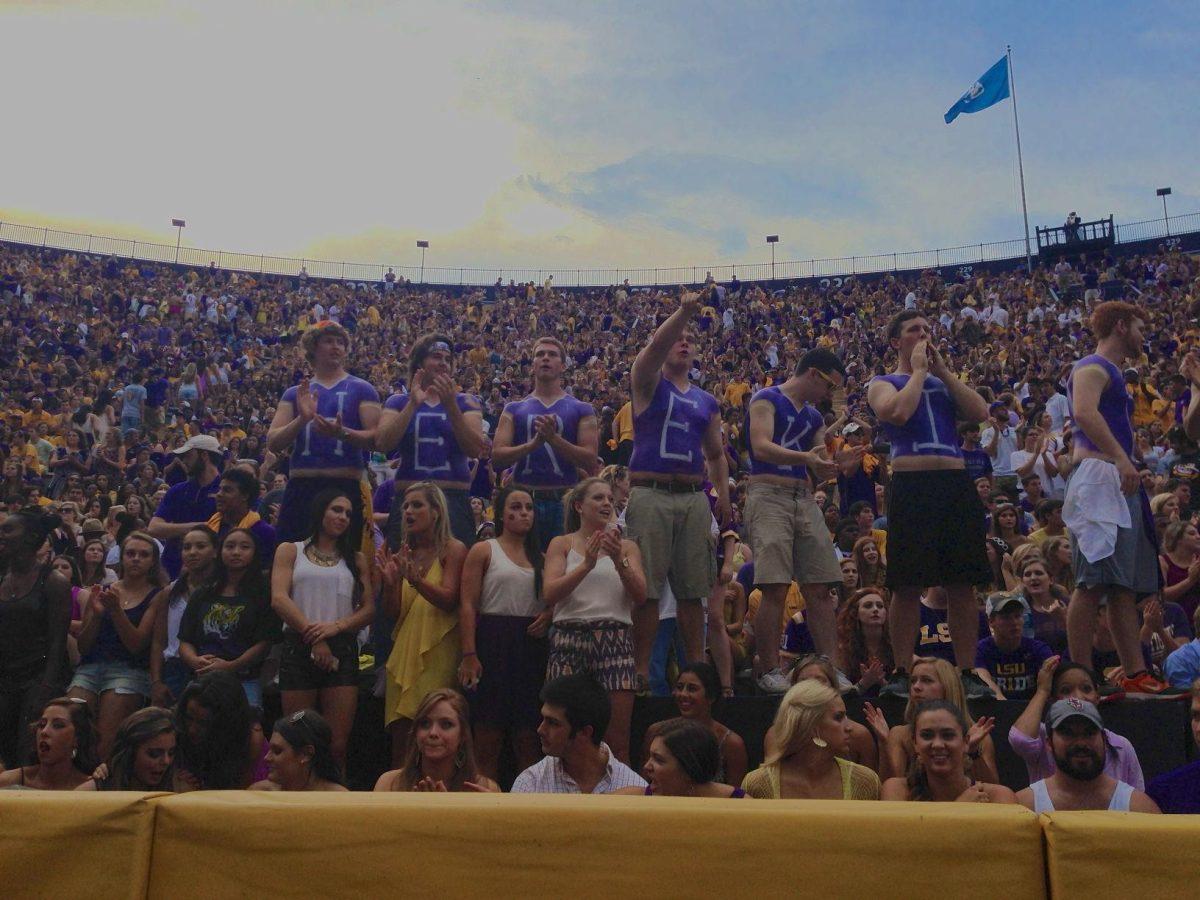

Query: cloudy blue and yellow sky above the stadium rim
[[0, 0, 1200, 278]]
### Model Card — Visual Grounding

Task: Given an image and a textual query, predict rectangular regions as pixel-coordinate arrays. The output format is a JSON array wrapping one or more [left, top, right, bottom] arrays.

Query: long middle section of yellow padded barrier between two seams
[[150, 792, 1045, 900]]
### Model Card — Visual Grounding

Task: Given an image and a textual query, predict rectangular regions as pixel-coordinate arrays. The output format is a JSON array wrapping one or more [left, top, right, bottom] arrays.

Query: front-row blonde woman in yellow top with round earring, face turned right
[[742, 680, 880, 800]]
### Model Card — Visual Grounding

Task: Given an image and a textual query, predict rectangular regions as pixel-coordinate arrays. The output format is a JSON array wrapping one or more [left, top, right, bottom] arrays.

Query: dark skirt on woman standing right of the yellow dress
[[469, 616, 550, 728]]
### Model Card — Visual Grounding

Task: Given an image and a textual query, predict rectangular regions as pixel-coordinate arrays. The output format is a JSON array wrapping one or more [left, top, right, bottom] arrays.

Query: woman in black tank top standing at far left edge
[[0, 509, 71, 766]]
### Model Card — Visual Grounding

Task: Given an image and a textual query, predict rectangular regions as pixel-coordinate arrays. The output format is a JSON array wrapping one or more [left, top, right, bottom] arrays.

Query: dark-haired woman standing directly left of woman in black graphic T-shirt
[[150, 526, 217, 707]]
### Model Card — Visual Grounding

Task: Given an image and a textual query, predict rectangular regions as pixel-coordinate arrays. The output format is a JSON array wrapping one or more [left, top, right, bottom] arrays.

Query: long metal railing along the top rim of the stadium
[[0, 212, 1200, 287]]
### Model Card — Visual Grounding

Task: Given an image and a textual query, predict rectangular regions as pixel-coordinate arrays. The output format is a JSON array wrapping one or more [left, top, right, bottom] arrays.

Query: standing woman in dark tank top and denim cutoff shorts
[[67, 532, 167, 757]]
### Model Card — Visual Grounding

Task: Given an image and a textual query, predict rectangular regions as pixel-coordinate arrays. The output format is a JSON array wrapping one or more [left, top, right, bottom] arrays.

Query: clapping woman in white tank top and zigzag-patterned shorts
[[545, 478, 646, 762]]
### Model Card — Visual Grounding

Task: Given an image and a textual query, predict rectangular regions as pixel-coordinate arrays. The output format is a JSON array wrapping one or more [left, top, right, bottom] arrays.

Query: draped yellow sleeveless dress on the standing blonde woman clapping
[[384, 559, 461, 724]]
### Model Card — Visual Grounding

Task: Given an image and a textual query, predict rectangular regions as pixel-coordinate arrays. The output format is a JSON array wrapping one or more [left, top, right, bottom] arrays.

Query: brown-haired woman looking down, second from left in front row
[[76, 707, 175, 792]]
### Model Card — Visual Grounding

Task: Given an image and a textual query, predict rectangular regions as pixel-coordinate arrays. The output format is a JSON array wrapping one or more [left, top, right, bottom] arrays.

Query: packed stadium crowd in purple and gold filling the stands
[[0, 237, 1200, 812]]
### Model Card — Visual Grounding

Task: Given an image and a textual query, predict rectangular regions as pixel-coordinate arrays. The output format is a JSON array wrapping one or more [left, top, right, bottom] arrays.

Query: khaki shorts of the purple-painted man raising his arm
[[625, 485, 716, 600]]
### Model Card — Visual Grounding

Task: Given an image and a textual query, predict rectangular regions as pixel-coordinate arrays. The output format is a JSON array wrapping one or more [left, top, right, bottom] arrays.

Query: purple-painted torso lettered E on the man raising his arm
[[629, 376, 720, 475]]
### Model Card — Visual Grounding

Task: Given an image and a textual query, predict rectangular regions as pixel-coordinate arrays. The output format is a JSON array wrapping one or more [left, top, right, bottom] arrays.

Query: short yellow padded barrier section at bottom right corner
[[1042, 811, 1200, 900]]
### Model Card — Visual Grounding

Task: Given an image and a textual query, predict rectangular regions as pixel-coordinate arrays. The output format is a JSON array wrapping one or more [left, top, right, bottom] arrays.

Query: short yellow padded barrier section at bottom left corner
[[0, 791, 161, 900]]
